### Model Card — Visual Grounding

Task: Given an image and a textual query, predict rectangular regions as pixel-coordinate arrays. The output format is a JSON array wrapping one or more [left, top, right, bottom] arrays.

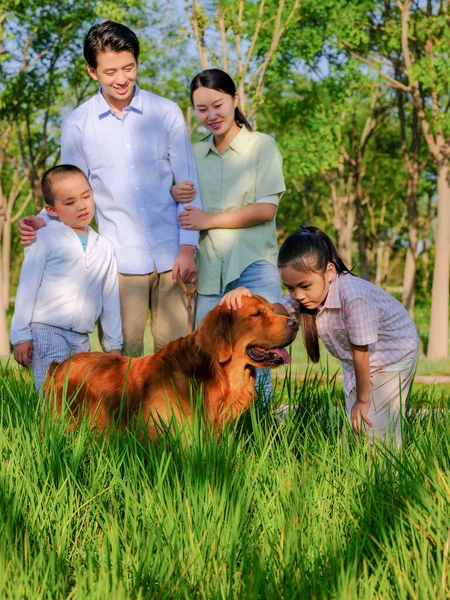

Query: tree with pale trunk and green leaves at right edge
[[328, 0, 450, 358]]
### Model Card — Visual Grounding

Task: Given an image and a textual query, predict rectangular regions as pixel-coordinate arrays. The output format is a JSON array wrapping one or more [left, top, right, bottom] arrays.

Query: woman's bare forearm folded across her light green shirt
[[178, 202, 277, 231]]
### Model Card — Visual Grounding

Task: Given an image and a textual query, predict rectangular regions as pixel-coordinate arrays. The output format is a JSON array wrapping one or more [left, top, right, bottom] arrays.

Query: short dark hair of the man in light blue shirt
[[84, 21, 140, 69]]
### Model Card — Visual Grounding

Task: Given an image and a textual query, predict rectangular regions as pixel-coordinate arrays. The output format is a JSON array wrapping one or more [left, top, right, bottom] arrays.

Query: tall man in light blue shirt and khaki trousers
[[19, 21, 201, 356]]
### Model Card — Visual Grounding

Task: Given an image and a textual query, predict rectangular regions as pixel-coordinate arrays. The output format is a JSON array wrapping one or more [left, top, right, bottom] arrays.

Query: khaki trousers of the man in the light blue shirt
[[119, 270, 187, 356]]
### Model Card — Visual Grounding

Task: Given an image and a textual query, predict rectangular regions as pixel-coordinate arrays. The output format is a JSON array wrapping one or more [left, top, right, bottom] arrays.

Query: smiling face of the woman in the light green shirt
[[192, 87, 239, 138]]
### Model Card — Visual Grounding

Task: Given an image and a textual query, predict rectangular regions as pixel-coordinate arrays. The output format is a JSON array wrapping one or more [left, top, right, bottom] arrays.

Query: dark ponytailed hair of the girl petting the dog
[[278, 227, 351, 363]]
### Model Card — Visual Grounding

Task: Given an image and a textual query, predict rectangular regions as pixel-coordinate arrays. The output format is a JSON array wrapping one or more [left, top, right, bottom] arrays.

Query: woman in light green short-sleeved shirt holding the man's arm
[[172, 69, 285, 398]]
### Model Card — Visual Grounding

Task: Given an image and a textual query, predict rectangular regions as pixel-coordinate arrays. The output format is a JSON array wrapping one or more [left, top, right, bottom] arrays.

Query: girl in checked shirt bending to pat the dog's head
[[223, 227, 419, 447]]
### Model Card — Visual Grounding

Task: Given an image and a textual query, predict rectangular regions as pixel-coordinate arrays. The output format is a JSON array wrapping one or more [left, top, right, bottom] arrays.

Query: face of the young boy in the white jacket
[[45, 173, 94, 233]]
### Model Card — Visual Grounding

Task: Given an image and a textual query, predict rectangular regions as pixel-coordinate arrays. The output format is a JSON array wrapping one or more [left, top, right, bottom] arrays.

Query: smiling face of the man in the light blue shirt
[[87, 51, 137, 110]]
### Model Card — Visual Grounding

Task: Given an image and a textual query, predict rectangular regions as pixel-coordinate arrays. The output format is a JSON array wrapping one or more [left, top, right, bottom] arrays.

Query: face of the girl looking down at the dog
[[280, 263, 336, 310]]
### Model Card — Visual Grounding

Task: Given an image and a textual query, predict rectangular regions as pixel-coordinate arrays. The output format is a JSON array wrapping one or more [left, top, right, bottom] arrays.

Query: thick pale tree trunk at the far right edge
[[427, 159, 450, 358]]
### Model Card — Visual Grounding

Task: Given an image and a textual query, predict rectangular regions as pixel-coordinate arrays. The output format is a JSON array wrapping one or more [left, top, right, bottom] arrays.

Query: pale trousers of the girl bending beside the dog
[[345, 360, 417, 448]]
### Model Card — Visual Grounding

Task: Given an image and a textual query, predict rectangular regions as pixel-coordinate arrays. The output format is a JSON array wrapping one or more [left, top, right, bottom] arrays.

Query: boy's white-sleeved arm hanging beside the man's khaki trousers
[[100, 249, 123, 354]]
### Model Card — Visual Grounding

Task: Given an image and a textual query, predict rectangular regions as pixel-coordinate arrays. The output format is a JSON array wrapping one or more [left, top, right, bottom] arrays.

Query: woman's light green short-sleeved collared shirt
[[194, 127, 286, 294]]
